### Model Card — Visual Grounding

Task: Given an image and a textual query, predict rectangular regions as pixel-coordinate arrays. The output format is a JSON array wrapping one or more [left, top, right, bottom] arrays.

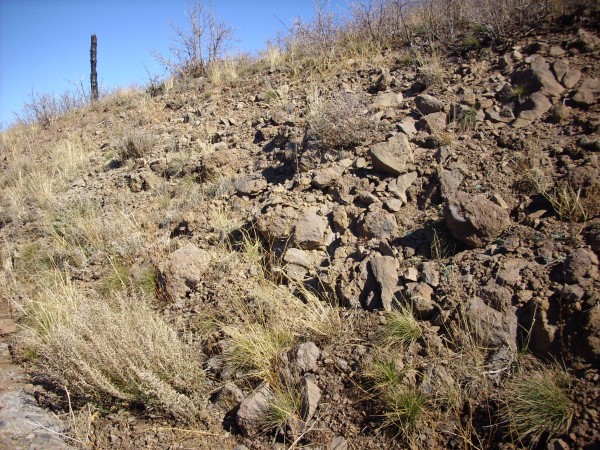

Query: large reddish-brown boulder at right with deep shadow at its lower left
[[444, 191, 510, 247]]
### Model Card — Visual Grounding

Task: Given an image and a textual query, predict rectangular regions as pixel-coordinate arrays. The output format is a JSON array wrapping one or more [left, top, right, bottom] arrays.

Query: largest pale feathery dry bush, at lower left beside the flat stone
[[24, 272, 204, 423]]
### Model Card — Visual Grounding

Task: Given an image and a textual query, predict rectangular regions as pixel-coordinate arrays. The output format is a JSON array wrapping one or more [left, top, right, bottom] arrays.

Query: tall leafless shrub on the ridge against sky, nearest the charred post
[[154, 0, 233, 77]]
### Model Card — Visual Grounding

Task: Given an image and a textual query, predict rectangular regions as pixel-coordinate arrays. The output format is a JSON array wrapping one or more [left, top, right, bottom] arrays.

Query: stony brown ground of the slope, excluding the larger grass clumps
[[0, 12, 600, 450]]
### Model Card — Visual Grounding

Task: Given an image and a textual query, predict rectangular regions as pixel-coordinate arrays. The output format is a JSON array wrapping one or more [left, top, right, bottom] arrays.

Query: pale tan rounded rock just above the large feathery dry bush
[[159, 244, 211, 301]]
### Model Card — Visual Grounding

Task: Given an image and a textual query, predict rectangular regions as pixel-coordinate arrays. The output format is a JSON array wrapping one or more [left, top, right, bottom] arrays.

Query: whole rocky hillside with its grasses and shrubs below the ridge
[[0, 6, 600, 450]]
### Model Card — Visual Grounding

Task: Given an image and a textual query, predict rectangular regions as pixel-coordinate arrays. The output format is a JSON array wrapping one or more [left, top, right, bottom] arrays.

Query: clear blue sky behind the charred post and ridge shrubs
[[0, 0, 346, 126]]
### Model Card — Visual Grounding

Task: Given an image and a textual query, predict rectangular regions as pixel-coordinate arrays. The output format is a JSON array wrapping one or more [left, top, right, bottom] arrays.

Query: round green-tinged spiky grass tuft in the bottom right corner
[[502, 368, 574, 447]]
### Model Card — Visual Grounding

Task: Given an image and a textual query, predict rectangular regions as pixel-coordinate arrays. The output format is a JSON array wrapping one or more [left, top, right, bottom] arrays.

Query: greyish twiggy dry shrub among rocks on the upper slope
[[307, 92, 376, 150]]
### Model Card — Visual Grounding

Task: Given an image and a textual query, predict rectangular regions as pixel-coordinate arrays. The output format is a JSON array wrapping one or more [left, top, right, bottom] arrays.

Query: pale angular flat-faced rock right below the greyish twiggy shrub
[[369, 133, 413, 175]]
